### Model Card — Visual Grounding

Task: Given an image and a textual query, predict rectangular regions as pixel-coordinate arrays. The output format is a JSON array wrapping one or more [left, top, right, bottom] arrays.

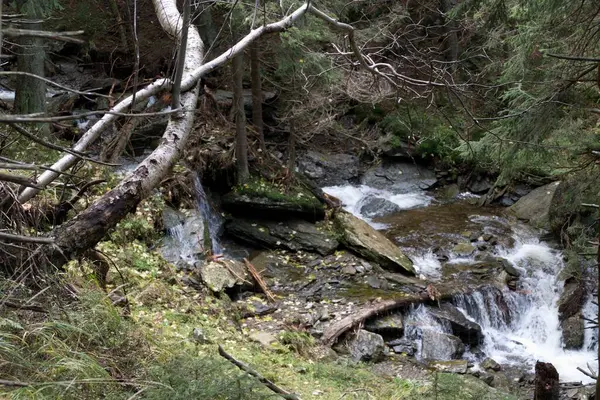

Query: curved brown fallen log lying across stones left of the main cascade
[[321, 285, 485, 346]]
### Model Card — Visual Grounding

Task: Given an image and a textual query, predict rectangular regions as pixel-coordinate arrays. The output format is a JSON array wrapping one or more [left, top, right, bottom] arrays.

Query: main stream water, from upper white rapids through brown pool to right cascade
[[324, 182, 597, 382]]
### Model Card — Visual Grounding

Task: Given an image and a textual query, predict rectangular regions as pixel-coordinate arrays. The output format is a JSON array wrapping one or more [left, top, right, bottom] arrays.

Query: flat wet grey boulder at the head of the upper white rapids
[[361, 163, 437, 193]]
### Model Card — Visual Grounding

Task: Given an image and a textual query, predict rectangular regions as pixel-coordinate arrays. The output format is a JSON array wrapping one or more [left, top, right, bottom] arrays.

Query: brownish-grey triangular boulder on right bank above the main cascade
[[509, 181, 561, 229]]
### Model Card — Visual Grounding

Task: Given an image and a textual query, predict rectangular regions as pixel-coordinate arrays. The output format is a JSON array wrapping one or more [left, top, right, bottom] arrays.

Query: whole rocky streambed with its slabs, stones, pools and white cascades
[[158, 160, 597, 398]]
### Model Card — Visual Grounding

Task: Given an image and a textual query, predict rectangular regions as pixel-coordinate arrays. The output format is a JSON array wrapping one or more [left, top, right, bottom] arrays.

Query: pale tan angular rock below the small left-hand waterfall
[[197, 260, 252, 293]]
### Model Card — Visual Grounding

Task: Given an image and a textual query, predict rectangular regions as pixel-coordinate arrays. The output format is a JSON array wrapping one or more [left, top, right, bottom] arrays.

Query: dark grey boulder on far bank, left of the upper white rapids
[[297, 150, 360, 186]]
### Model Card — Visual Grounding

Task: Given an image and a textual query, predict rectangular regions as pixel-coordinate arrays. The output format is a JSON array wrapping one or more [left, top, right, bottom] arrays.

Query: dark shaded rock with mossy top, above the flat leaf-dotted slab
[[222, 192, 325, 221]]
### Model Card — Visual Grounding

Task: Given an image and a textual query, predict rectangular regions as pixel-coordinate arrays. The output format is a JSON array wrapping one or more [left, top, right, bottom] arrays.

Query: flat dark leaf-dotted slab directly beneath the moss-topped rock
[[225, 218, 339, 256]]
